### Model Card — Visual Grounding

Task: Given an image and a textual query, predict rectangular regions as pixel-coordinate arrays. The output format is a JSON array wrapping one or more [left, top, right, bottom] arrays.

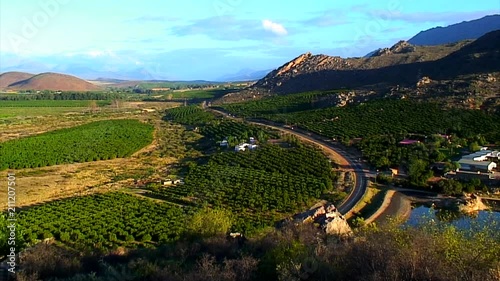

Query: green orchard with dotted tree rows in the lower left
[[12, 192, 191, 250]]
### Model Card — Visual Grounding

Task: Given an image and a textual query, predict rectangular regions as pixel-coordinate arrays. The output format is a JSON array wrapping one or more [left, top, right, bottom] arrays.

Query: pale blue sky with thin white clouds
[[0, 0, 500, 80]]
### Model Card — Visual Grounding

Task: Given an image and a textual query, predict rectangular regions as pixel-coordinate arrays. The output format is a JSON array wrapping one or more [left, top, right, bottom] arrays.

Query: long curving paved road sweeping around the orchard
[[210, 109, 373, 215]]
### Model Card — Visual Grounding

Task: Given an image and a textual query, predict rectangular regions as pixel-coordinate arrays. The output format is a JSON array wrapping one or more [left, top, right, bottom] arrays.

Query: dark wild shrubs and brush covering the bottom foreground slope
[[13, 219, 500, 281]]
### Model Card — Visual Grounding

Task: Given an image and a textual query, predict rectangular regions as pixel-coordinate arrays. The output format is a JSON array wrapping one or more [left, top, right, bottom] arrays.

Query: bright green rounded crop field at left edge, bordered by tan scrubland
[[0, 120, 153, 170]]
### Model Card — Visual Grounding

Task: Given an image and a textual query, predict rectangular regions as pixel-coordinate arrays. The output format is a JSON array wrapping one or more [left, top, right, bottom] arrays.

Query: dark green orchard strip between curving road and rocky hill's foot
[[225, 97, 500, 140]]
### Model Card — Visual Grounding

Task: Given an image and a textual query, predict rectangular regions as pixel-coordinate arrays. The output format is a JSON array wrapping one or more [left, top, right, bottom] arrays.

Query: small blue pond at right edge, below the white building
[[407, 205, 500, 229]]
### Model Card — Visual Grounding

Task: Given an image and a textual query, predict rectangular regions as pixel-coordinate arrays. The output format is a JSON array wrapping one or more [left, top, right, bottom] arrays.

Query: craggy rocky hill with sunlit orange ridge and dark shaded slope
[[223, 31, 500, 110]]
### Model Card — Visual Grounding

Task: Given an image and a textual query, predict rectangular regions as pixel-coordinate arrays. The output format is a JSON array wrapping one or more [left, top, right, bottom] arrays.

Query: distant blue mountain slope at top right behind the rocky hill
[[408, 15, 500, 46]]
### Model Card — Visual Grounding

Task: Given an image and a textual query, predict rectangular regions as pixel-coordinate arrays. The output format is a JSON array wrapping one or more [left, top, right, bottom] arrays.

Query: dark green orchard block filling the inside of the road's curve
[[146, 145, 335, 233]]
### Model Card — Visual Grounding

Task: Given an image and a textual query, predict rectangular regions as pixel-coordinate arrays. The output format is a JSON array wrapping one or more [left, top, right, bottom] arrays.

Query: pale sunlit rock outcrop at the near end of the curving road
[[295, 203, 352, 236]]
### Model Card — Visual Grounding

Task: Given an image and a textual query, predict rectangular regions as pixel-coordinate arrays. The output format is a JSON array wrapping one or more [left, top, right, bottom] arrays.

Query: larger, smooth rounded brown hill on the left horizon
[[8, 72, 101, 91]]
